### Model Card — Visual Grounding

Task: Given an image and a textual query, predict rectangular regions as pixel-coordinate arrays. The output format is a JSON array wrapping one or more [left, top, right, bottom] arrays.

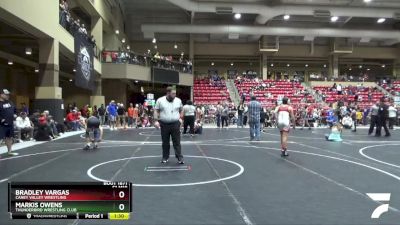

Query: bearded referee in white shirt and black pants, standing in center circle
[[154, 87, 184, 164]]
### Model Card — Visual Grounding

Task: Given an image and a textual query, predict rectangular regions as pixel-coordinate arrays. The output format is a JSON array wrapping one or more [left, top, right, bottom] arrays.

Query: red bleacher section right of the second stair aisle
[[313, 86, 384, 109]]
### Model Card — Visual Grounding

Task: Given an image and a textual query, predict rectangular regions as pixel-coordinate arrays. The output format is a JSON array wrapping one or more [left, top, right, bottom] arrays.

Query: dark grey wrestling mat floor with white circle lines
[[0, 128, 400, 225]]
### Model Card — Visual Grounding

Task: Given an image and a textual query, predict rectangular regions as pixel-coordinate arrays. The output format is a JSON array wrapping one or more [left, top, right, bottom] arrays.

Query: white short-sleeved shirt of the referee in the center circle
[[154, 96, 182, 123]]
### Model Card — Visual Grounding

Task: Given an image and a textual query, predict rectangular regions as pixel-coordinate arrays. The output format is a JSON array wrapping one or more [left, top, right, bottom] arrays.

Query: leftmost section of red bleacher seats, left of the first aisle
[[193, 79, 230, 105]]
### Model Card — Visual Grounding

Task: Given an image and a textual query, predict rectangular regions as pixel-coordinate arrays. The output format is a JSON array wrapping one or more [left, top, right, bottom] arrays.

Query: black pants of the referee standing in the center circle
[[160, 121, 183, 160]]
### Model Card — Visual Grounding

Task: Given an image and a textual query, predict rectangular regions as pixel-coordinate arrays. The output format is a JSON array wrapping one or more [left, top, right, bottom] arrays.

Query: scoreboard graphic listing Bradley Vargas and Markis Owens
[[8, 182, 132, 220]]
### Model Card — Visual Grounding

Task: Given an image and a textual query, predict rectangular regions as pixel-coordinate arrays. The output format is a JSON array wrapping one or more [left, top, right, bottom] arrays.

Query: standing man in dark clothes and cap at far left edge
[[0, 89, 18, 156]]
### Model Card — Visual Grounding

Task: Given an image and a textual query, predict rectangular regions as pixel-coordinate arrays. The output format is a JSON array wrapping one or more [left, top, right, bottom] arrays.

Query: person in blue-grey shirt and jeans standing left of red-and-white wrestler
[[248, 96, 261, 141]]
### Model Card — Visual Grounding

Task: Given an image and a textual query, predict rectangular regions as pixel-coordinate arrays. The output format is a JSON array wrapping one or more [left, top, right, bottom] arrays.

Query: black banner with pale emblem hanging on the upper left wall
[[75, 32, 95, 90]]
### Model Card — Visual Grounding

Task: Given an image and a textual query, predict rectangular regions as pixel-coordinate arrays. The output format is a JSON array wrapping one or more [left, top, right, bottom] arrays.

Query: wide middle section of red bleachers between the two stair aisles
[[235, 80, 315, 108]]
